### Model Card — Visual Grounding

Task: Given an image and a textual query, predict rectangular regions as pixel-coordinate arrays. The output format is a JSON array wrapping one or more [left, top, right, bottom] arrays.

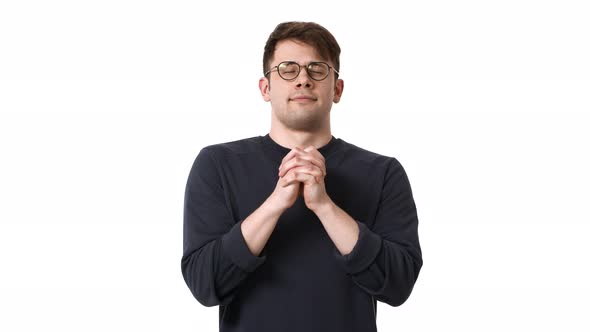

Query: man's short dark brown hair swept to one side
[[262, 22, 340, 77]]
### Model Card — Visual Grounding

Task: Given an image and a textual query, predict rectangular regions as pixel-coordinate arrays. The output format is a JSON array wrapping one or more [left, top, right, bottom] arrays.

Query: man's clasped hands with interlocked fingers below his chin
[[275, 145, 331, 211]]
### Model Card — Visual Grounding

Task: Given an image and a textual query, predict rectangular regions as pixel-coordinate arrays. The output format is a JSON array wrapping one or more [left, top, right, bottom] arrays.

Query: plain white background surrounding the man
[[0, 0, 590, 331]]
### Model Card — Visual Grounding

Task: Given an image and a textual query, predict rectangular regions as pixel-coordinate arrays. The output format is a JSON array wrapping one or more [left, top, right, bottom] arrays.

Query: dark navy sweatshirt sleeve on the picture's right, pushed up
[[334, 158, 422, 306]]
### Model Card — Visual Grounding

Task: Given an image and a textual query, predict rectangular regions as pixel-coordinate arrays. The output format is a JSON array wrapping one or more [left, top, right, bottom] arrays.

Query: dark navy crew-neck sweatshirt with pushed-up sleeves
[[181, 134, 422, 332]]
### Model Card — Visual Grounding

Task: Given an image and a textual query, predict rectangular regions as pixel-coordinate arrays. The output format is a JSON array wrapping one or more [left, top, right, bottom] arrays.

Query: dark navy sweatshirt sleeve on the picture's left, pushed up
[[181, 148, 266, 306]]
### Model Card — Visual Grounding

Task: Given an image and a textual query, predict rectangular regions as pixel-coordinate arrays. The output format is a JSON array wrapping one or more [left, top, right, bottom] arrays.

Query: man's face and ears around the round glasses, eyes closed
[[259, 40, 344, 132]]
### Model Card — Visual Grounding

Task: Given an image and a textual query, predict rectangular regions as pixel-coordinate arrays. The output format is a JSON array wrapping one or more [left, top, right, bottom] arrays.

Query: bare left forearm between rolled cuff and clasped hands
[[241, 196, 285, 256]]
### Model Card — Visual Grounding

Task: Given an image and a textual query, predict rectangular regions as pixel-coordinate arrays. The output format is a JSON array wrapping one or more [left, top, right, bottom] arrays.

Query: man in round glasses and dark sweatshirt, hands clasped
[[182, 22, 422, 332]]
